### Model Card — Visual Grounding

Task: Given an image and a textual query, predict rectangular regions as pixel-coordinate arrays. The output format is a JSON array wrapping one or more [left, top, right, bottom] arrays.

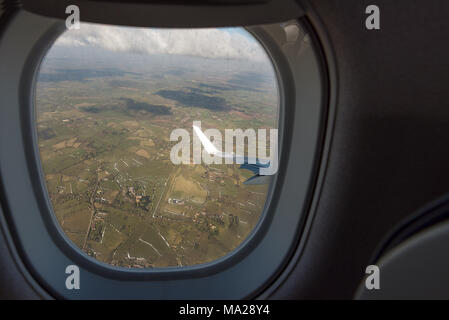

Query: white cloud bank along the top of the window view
[[55, 23, 267, 61]]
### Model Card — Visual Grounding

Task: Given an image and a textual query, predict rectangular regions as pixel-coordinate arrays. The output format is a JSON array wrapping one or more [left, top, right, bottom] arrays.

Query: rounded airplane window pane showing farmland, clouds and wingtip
[[36, 23, 279, 268]]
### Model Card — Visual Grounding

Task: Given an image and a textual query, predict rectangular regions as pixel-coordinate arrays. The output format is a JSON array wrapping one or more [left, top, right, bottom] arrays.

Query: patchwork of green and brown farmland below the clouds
[[36, 50, 278, 268]]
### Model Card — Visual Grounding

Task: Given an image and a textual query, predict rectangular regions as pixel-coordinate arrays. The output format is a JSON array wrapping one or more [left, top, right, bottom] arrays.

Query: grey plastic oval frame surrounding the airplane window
[[0, 11, 327, 299]]
